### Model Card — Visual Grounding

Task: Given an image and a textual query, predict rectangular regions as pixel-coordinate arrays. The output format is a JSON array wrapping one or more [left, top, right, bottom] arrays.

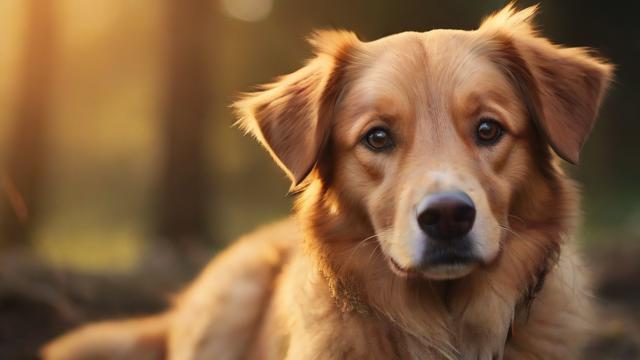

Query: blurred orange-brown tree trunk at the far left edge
[[0, 0, 56, 246]]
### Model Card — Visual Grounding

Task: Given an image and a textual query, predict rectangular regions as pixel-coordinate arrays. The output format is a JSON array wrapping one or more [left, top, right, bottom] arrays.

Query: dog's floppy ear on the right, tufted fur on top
[[479, 4, 613, 164]]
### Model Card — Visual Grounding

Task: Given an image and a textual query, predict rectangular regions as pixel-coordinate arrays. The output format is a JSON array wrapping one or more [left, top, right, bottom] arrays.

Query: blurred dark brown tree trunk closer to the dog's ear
[[156, 0, 213, 256]]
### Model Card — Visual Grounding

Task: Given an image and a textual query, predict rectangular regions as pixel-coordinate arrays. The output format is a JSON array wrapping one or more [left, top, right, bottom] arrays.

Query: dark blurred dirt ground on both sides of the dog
[[0, 242, 640, 360]]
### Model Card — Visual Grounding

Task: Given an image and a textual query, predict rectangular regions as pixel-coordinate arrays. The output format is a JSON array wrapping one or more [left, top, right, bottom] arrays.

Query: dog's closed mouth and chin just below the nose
[[388, 249, 480, 280]]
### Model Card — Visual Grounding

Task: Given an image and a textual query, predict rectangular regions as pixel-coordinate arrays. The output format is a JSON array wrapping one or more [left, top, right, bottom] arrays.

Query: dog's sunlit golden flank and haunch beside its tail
[[169, 218, 302, 359]]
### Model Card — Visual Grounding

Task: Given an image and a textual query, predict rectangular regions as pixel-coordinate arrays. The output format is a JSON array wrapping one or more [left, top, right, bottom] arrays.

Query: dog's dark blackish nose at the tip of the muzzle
[[418, 192, 476, 240]]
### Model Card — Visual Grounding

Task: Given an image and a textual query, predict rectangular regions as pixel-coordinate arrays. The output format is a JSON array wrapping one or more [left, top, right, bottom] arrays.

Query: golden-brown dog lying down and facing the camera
[[43, 5, 613, 360]]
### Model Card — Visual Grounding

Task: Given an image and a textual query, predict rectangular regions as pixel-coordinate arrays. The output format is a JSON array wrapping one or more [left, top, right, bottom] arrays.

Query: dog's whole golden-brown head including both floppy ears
[[236, 6, 612, 279]]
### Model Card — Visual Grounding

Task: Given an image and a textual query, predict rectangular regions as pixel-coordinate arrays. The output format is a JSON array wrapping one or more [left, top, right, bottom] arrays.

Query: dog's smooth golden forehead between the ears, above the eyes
[[348, 30, 508, 115]]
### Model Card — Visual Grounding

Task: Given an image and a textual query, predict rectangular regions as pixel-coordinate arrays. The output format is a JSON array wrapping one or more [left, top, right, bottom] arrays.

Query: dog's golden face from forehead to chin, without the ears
[[331, 30, 533, 278]]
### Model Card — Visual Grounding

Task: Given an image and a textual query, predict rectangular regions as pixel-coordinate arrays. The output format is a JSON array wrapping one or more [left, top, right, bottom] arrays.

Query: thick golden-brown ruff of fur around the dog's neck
[[298, 160, 577, 358]]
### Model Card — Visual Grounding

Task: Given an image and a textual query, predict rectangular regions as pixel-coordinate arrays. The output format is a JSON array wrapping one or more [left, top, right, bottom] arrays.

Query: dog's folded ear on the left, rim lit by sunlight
[[233, 31, 359, 188]]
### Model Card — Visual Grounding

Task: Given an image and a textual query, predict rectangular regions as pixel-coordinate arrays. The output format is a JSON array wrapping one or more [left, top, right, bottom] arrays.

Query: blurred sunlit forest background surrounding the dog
[[0, 0, 640, 359]]
